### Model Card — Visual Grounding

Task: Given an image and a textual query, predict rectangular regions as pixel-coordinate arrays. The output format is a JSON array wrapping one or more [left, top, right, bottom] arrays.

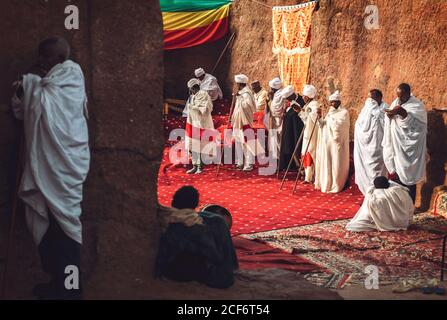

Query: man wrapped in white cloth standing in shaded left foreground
[[12, 38, 90, 299]]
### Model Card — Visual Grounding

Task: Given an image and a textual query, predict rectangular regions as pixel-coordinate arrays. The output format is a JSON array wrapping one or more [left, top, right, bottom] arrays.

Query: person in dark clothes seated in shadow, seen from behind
[[155, 186, 238, 289]]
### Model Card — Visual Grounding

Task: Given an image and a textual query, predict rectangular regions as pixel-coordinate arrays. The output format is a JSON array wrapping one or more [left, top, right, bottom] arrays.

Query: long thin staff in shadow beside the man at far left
[[0, 133, 25, 299]]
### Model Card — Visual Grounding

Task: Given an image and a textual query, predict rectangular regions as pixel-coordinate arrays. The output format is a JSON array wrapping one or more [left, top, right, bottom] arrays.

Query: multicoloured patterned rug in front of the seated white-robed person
[[244, 213, 447, 289]]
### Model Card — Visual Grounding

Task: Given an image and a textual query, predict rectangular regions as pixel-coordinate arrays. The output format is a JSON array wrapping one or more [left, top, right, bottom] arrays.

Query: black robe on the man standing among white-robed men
[[279, 96, 304, 170]]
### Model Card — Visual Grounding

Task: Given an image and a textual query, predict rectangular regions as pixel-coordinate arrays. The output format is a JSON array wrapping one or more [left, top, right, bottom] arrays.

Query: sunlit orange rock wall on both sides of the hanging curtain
[[225, 0, 447, 209]]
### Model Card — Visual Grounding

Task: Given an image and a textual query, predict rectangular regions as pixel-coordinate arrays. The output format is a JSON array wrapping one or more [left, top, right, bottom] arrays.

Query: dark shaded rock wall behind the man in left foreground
[[0, 0, 163, 298]]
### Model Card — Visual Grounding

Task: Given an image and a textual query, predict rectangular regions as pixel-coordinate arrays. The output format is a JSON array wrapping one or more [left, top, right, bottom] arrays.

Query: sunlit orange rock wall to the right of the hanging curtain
[[311, 0, 447, 209]]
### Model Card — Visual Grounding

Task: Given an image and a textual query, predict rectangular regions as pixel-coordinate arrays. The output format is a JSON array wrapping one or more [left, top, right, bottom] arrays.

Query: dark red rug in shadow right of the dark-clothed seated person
[[233, 237, 322, 273]]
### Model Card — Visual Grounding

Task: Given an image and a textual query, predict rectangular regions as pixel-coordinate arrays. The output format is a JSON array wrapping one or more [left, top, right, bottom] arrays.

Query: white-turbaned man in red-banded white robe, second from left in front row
[[231, 74, 256, 172]]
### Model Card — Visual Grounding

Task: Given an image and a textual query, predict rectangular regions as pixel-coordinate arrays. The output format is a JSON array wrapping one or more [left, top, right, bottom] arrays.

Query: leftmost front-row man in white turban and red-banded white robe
[[185, 79, 214, 174]]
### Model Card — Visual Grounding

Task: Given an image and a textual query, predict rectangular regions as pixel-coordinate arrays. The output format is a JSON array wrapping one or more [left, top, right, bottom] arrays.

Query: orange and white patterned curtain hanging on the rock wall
[[272, 1, 317, 91]]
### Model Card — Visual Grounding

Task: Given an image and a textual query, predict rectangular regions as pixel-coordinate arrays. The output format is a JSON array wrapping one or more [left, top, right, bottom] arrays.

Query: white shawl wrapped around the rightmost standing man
[[383, 96, 427, 185]]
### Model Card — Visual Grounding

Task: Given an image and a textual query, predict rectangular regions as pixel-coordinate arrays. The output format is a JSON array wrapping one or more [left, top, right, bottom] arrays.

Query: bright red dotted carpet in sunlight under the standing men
[[158, 111, 363, 235]]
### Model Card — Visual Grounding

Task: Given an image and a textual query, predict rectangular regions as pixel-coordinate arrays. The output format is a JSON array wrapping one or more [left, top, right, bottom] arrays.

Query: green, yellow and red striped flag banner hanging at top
[[160, 0, 231, 50]]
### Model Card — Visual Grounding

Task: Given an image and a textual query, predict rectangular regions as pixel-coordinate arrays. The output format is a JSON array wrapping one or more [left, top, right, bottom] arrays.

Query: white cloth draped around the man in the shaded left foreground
[[13, 60, 90, 244]]
